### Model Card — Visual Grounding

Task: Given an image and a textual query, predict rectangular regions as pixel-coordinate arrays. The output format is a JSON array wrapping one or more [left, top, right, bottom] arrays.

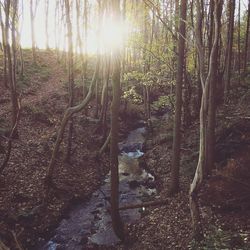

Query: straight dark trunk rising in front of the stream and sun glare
[[110, 0, 124, 239]]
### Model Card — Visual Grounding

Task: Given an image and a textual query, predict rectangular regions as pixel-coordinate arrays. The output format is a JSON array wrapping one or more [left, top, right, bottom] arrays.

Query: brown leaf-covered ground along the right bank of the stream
[[120, 78, 250, 250]]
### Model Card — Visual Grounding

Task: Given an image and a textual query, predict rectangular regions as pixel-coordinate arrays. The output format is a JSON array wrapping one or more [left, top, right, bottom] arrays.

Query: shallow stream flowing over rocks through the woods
[[41, 128, 156, 250]]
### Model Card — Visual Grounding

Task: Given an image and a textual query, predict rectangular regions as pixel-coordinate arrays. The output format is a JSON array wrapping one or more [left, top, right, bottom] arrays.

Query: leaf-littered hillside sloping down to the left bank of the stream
[[0, 51, 115, 249]]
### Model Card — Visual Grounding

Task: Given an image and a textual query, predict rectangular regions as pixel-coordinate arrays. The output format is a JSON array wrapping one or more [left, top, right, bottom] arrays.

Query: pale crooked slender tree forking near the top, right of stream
[[189, 0, 223, 240]]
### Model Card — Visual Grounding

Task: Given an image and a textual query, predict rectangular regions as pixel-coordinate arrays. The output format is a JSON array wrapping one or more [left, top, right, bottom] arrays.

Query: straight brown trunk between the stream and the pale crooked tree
[[169, 0, 187, 194]]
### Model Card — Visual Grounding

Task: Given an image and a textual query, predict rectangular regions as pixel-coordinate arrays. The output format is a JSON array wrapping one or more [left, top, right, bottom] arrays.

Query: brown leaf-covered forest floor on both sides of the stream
[[0, 51, 250, 250]]
